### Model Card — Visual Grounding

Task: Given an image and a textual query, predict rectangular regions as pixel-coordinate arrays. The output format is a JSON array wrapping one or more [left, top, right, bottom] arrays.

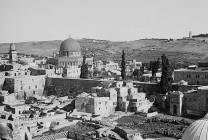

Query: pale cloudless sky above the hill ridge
[[0, 0, 208, 43]]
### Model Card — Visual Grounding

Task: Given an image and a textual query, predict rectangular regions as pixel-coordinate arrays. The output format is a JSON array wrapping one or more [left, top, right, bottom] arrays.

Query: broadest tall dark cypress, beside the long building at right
[[160, 54, 173, 94]]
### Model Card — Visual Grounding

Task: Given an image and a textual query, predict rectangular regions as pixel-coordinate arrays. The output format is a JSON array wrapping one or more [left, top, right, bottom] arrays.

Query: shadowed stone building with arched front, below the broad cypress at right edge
[[169, 86, 208, 116]]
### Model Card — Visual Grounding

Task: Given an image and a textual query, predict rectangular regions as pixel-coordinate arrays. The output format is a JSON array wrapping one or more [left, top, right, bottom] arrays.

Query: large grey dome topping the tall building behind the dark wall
[[60, 38, 81, 52]]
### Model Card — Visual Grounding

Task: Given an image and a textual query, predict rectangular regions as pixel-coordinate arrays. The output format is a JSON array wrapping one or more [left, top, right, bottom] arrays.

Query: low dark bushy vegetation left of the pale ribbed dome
[[117, 115, 193, 139]]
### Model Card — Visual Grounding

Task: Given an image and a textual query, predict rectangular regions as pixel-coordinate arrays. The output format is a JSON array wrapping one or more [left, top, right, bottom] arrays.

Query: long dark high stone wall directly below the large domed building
[[44, 77, 102, 96]]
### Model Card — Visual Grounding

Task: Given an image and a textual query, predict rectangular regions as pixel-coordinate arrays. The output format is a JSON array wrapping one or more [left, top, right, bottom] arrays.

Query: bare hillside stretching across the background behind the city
[[0, 39, 208, 63]]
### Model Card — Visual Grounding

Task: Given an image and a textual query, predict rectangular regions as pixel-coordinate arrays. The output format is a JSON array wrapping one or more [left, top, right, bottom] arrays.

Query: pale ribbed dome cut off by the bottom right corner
[[181, 115, 208, 140]]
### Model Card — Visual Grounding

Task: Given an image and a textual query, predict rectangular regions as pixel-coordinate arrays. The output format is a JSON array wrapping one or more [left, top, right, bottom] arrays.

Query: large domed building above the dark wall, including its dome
[[58, 37, 93, 78]]
